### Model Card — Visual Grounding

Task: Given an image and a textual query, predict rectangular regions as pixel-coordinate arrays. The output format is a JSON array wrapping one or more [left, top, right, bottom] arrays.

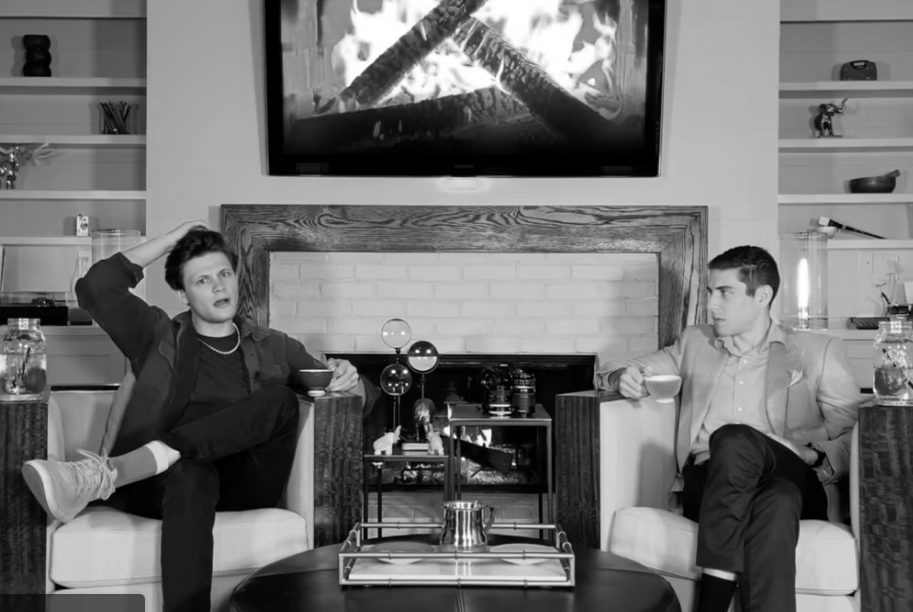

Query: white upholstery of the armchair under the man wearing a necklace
[[46, 374, 314, 612]]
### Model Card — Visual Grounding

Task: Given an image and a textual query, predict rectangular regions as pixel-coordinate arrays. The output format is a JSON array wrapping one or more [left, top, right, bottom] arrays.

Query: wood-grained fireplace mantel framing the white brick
[[221, 204, 707, 346]]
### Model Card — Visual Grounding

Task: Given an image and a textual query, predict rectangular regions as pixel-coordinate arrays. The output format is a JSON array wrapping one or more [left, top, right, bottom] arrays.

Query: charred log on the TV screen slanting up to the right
[[318, 0, 487, 113]]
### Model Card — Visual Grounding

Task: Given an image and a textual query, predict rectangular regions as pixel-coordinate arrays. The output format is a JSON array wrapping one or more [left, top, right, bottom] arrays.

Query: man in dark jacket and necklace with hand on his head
[[22, 221, 377, 612]]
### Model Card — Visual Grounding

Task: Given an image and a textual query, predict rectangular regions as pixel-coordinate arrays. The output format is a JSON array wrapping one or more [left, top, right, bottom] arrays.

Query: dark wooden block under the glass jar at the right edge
[[859, 404, 913, 612]]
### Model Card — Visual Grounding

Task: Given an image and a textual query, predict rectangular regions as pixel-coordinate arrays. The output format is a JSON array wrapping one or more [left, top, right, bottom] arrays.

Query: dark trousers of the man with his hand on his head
[[109, 387, 298, 612]]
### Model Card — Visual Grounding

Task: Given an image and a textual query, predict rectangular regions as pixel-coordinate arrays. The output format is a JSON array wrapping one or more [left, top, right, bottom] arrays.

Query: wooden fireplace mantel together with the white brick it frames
[[221, 205, 707, 359]]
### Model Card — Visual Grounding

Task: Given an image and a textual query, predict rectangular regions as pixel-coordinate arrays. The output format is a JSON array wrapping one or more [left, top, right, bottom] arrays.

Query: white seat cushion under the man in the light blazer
[[609, 508, 859, 595]]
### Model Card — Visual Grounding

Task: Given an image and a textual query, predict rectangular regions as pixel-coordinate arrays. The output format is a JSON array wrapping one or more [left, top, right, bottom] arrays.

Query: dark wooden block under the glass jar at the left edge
[[0, 389, 50, 594]]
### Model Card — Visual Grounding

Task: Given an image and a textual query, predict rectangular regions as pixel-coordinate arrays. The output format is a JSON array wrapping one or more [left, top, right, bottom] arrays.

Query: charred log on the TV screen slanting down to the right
[[453, 18, 636, 146]]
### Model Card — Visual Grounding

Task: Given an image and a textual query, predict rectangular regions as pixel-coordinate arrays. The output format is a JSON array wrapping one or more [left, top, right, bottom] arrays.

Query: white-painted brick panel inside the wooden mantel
[[269, 252, 659, 366]]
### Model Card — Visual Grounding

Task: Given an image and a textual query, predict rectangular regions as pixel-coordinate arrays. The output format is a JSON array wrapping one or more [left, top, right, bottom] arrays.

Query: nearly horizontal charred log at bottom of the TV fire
[[290, 87, 530, 153]]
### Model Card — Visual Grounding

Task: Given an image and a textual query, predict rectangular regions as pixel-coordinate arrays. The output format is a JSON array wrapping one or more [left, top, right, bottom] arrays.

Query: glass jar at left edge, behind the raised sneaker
[[0, 319, 48, 402]]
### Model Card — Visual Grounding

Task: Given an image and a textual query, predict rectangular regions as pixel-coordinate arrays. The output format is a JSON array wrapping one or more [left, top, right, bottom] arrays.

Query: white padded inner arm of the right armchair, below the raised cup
[[599, 398, 678, 550]]
